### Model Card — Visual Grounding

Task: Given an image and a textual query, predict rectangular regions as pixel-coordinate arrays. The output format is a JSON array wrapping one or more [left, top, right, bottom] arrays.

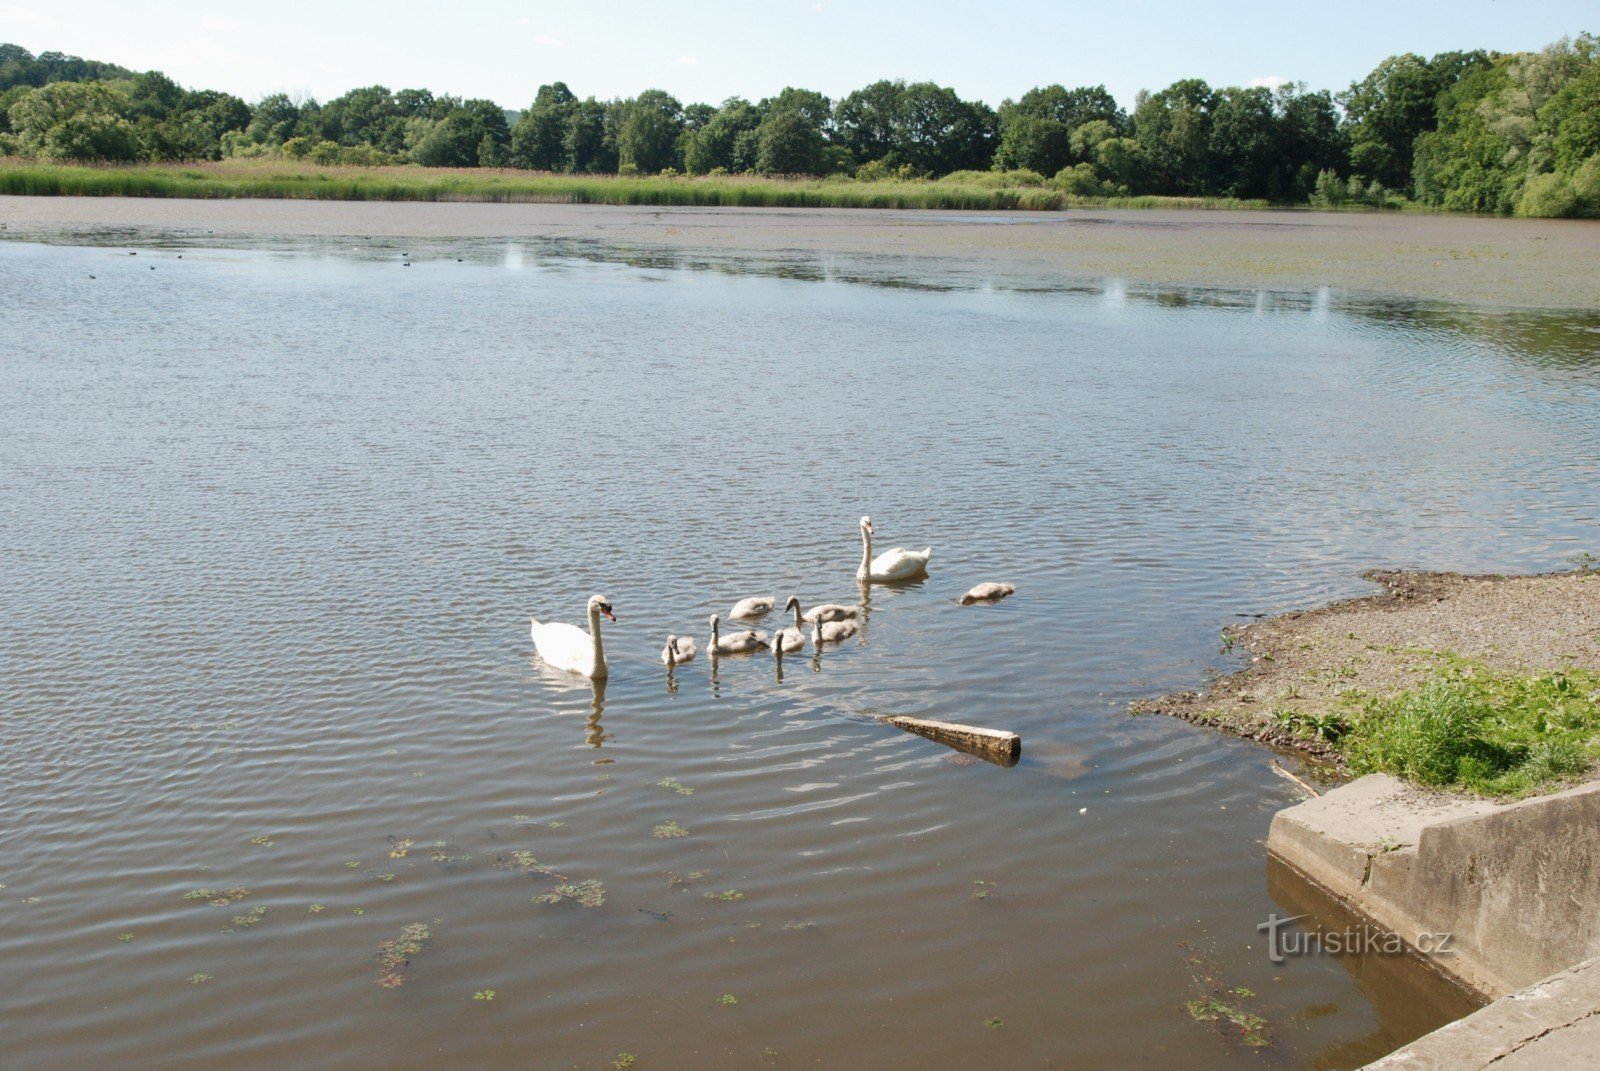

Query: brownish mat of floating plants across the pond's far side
[[9, 197, 1600, 309]]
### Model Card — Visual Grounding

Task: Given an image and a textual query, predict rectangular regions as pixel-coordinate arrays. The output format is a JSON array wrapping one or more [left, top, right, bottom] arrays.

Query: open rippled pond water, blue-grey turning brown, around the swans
[[0, 224, 1600, 1071]]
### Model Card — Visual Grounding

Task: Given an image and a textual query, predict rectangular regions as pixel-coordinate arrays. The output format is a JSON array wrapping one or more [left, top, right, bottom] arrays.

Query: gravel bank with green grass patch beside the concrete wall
[[1133, 566, 1600, 797]]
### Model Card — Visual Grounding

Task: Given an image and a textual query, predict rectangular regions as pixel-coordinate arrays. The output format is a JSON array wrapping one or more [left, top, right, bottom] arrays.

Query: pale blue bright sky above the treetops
[[0, 0, 1600, 107]]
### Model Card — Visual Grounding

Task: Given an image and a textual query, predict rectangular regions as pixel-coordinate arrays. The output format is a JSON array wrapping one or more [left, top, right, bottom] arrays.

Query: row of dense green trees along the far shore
[[0, 34, 1600, 216]]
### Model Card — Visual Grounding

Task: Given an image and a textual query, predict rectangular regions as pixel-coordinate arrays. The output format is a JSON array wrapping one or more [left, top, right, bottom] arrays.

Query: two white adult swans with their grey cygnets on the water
[[530, 517, 1016, 680]]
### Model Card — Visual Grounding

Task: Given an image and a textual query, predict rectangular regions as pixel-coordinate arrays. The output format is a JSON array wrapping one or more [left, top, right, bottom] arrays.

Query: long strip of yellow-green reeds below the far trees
[[0, 160, 1264, 211]]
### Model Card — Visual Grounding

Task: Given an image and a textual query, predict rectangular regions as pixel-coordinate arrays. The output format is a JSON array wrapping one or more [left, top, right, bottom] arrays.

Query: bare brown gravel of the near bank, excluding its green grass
[[1133, 570, 1600, 762]]
